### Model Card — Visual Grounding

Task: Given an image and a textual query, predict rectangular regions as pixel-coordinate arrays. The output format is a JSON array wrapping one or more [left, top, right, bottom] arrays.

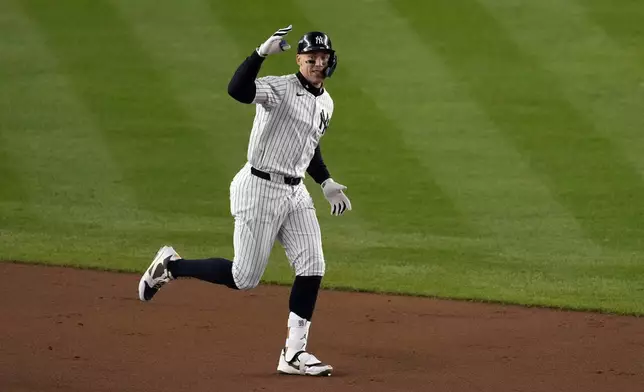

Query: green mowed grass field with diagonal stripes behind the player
[[0, 0, 644, 314]]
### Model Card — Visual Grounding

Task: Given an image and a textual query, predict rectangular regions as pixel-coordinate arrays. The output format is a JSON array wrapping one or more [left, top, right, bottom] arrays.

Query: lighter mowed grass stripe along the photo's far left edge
[[0, 0, 153, 263]]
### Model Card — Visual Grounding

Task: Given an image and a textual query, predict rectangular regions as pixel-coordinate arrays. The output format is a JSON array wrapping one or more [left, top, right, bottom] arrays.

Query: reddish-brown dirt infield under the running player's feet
[[0, 263, 644, 392]]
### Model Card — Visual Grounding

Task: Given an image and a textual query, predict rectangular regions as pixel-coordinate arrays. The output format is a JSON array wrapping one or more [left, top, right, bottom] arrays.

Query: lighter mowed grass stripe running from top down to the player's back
[[112, 0, 252, 188]]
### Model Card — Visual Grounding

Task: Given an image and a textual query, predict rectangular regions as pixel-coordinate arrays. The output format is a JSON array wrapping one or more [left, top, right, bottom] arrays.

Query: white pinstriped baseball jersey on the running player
[[248, 74, 333, 177]]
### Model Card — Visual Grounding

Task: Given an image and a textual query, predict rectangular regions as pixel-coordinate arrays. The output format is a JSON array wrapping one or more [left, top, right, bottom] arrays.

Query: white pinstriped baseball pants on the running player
[[230, 163, 325, 290]]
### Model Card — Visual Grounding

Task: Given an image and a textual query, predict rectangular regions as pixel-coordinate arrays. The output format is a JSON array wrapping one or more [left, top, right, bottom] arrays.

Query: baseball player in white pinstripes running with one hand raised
[[139, 26, 351, 376]]
